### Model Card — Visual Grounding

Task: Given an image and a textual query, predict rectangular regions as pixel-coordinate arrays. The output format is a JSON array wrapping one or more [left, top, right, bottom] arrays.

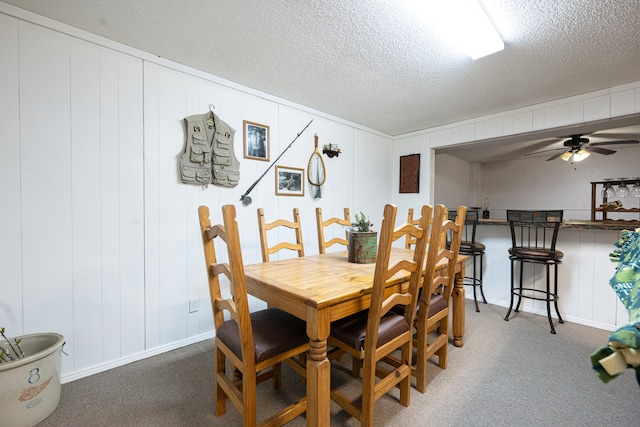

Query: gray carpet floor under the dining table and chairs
[[39, 301, 640, 427]]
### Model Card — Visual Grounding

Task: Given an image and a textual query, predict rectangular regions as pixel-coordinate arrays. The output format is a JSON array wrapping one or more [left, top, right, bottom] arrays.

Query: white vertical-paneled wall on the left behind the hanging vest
[[0, 8, 393, 381]]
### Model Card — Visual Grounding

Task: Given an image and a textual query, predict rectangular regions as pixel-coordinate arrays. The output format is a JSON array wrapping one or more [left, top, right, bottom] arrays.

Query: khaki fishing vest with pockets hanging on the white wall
[[180, 112, 240, 187]]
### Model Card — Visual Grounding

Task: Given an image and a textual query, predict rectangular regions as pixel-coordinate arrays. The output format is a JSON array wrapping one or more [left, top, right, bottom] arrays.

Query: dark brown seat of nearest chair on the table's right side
[[331, 310, 409, 350]]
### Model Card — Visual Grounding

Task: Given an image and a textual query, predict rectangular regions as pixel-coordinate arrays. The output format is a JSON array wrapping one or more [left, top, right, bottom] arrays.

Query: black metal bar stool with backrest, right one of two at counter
[[504, 210, 564, 334]]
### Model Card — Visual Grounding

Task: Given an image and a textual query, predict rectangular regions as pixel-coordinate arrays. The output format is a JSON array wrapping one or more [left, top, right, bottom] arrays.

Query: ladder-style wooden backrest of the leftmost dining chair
[[198, 205, 255, 363]]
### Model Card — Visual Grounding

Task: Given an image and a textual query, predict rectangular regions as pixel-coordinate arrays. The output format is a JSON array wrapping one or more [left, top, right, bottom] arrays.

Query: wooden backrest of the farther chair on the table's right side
[[420, 205, 467, 313]]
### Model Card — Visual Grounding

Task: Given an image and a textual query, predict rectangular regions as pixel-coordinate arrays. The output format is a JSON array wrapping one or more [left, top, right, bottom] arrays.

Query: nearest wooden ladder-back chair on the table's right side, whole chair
[[329, 204, 431, 426]]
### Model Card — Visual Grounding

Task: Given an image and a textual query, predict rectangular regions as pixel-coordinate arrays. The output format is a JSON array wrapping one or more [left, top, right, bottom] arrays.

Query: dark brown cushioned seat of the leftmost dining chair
[[216, 308, 309, 363]]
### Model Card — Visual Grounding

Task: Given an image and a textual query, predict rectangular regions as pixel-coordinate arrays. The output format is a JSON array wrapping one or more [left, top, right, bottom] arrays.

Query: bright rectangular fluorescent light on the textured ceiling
[[408, 0, 504, 60]]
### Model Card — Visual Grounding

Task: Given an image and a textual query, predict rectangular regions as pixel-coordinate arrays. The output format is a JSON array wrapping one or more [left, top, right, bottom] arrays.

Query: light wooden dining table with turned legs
[[245, 248, 467, 426]]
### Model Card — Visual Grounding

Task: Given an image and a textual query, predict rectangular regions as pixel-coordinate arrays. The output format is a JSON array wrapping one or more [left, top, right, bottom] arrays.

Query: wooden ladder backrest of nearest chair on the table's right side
[[364, 204, 431, 360]]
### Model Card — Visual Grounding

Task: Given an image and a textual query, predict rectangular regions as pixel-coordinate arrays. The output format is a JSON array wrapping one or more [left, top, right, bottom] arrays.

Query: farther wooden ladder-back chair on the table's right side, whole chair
[[413, 205, 467, 393]]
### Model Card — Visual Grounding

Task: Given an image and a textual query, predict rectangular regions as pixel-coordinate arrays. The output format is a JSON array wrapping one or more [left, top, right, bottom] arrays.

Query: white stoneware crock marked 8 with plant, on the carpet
[[0, 328, 64, 427]]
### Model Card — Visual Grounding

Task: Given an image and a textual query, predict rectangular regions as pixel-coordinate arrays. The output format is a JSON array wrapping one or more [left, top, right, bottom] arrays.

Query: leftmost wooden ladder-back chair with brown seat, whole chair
[[198, 205, 309, 427]]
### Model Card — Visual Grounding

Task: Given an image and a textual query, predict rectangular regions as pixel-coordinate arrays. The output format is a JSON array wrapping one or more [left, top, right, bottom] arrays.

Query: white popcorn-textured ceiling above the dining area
[[3, 0, 640, 160]]
